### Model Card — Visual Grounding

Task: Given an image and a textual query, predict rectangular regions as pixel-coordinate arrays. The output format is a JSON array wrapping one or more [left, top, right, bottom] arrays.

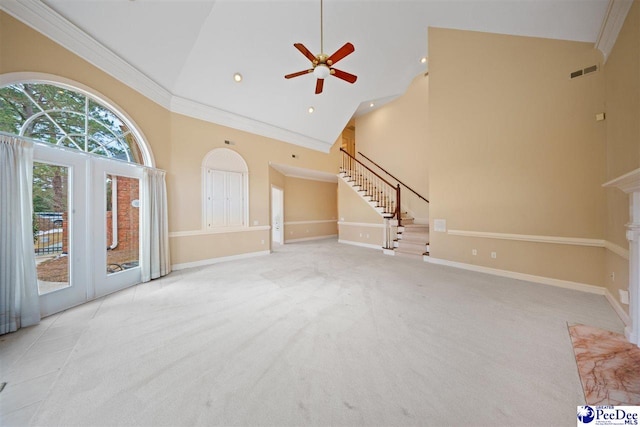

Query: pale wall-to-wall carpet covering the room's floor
[[11, 240, 623, 426]]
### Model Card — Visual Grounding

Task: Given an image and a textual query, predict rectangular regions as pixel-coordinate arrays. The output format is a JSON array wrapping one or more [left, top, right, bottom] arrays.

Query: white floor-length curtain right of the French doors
[[140, 168, 171, 282]]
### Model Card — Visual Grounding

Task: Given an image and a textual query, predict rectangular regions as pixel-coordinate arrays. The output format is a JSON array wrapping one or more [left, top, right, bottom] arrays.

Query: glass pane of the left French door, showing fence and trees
[[33, 162, 70, 295]]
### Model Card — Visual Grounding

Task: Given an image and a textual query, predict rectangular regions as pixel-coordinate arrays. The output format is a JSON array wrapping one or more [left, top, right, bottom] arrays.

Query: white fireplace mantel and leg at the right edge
[[603, 169, 640, 346]]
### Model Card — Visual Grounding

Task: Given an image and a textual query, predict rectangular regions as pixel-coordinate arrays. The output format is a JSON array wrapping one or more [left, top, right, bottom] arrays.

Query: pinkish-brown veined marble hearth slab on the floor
[[569, 325, 640, 406]]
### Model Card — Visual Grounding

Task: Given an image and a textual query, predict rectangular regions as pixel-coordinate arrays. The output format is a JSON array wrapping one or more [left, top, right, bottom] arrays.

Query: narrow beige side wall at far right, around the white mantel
[[604, 1, 640, 309]]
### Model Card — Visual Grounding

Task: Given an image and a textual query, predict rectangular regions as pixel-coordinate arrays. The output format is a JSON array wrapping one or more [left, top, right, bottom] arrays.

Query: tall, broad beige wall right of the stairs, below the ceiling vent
[[428, 28, 605, 286]]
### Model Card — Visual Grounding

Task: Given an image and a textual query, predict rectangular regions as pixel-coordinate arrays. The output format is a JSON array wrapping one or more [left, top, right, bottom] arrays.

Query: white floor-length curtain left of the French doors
[[0, 135, 40, 335]]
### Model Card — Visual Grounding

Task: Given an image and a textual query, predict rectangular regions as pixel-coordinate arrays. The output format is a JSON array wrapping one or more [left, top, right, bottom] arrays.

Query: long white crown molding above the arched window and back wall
[[0, 0, 332, 153]]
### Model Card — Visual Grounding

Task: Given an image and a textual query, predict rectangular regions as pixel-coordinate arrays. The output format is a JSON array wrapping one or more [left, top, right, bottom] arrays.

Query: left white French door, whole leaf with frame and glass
[[33, 146, 89, 316]]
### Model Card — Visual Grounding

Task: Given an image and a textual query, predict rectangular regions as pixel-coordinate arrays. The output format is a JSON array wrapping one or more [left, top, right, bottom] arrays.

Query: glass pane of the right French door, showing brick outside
[[106, 175, 140, 274]]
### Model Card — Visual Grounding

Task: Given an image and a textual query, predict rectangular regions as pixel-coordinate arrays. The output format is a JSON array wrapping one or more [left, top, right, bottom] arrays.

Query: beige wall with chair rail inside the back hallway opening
[[284, 176, 338, 243]]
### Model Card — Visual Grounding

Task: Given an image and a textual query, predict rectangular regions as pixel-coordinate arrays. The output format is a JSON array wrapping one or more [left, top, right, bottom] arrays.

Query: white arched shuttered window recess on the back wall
[[202, 148, 249, 229]]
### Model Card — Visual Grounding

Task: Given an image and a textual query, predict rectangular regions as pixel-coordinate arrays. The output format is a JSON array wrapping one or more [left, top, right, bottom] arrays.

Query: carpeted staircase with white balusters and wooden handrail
[[338, 149, 429, 259]]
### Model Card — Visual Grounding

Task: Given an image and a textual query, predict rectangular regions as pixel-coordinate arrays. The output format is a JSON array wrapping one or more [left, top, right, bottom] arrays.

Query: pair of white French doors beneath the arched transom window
[[33, 145, 142, 316]]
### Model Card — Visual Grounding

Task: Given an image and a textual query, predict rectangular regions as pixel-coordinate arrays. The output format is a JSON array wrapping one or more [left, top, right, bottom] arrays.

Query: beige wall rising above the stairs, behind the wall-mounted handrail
[[356, 74, 429, 221]]
